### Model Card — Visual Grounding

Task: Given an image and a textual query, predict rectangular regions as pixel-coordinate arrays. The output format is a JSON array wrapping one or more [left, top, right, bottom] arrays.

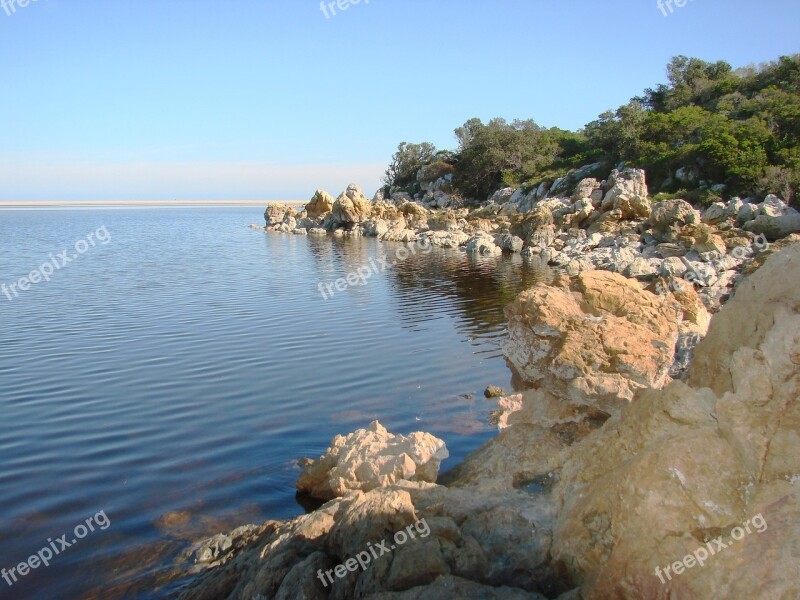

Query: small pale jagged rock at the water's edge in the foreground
[[297, 421, 449, 500]]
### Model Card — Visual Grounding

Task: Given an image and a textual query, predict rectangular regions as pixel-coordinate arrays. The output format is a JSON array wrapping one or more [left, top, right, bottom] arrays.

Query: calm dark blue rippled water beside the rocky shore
[[0, 208, 552, 600]]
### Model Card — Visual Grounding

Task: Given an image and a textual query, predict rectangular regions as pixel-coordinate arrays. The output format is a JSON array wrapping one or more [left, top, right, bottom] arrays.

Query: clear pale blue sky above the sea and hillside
[[0, 0, 800, 201]]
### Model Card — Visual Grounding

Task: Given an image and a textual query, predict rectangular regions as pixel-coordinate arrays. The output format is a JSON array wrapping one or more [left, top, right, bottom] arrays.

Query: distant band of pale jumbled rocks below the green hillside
[[258, 172, 800, 322]]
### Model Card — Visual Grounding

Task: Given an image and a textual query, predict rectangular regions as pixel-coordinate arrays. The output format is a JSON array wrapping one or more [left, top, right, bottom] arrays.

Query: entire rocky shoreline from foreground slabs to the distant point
[[180, 169, 800, 600]]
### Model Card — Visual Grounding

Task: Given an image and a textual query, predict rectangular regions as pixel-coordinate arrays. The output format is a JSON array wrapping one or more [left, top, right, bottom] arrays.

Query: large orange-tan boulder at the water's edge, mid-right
[[503, 271, 680, 404]]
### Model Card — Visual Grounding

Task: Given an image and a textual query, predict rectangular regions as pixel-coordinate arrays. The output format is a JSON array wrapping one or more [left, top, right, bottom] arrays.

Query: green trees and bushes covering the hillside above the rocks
[[384, 54, 800, 209]]
